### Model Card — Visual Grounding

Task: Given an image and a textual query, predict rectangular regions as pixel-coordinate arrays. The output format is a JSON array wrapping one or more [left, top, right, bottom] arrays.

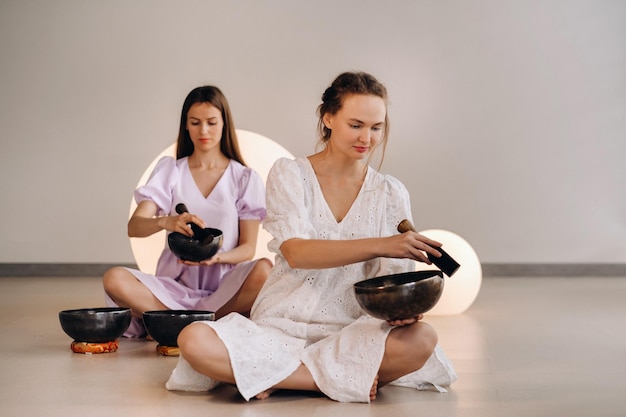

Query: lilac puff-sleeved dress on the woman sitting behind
[[106, 157, 266, 337]]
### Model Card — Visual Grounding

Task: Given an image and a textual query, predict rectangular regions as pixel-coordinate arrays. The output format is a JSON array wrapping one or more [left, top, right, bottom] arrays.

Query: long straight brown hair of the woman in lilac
[[176, 85, 245, 165]]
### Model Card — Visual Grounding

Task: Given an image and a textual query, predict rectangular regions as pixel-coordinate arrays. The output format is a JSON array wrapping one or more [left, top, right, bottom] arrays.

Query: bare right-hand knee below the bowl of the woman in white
[[378, 322, 437, 385]]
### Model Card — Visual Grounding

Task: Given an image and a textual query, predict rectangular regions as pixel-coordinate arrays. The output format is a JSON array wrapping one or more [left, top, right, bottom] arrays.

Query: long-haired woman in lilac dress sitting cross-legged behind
[[103, 86, 272, 337]]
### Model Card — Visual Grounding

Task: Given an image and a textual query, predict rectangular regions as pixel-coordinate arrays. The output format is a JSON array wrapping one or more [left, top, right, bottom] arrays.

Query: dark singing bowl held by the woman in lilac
[[167, 227, 223, 262]]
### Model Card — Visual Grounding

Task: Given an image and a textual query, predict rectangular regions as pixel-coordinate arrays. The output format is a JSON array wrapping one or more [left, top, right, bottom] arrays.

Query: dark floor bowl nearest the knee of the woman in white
[[143, 310, 215, 347]]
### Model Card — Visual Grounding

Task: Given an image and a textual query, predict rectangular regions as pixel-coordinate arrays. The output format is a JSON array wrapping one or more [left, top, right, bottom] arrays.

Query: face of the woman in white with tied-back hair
[[324, 94, 387, 159]]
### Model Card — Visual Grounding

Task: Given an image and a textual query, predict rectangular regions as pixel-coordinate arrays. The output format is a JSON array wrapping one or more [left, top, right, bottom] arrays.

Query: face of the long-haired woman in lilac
[[186, 103, 224, 152]]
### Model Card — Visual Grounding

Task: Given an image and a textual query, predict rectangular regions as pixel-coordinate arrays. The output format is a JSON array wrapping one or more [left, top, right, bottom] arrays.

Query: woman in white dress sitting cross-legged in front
[[166, 72, 456, 402]]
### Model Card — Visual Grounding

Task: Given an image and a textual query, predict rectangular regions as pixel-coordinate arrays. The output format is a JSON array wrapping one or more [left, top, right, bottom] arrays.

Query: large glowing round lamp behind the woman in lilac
[[128, 129, 293, 274]]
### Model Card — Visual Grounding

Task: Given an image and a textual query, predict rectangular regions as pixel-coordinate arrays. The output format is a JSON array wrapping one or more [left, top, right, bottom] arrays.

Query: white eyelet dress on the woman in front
[[166, 158, 456, 402]]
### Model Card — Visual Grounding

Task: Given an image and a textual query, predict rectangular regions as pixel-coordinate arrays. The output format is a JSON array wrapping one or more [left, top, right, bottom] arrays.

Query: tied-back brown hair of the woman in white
[[317, 71, 389, 164]]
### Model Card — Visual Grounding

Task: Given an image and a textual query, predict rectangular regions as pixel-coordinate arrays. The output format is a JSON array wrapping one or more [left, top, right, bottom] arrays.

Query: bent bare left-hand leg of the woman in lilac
[[102, 267, 167, 318]]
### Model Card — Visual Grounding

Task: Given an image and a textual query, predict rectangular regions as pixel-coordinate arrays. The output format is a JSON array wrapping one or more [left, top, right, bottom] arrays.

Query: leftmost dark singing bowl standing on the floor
[[59, 307, 131, 343]]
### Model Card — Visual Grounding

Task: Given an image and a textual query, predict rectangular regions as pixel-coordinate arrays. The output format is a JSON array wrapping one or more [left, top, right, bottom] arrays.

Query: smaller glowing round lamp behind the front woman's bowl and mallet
[[416, 229, 483, 316]]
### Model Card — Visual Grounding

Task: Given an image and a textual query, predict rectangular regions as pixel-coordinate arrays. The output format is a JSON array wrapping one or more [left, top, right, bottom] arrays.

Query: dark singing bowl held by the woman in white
[[354, 271, 443, 320]]
